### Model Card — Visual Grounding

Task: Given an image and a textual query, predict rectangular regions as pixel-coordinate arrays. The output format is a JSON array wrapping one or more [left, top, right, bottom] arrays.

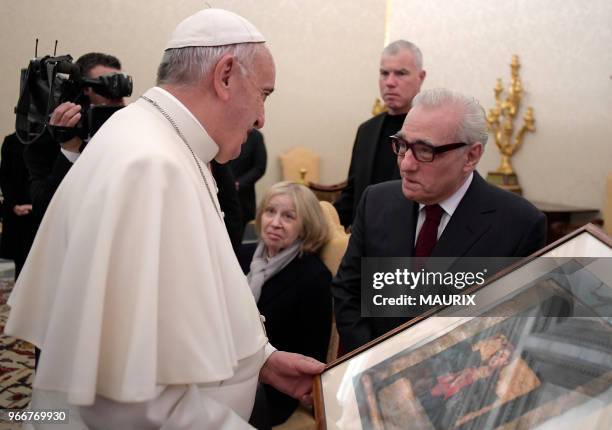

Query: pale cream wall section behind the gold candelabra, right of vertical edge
[[390, 0, 612, 208]]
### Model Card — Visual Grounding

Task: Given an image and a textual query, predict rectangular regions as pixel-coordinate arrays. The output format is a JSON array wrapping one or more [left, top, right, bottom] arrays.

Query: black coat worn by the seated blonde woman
[[239, 244, 332, 425]]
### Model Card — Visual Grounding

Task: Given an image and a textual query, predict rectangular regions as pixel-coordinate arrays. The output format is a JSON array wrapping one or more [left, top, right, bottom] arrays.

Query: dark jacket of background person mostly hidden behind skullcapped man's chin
[[230, 130, 268, 223]]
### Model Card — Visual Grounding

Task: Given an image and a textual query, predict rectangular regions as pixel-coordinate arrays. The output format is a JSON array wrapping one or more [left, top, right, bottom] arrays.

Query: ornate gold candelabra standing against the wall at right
[[487, 55, 535, 194]]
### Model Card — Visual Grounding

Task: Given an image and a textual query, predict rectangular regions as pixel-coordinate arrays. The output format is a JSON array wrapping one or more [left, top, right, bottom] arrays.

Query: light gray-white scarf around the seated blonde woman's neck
[[247, 240, 302, 302]]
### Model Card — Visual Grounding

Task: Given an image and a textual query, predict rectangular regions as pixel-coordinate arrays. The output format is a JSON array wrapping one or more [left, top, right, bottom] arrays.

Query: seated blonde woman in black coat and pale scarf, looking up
[[239, 182, 332, 425]]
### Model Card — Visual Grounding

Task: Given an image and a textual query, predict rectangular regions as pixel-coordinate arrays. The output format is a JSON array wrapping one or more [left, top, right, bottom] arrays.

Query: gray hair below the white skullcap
[[157, 43, 265, 86]]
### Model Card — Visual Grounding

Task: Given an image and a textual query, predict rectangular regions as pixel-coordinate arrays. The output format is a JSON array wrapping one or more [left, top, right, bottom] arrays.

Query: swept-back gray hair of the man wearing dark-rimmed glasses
[[412, 88, 489, 146]]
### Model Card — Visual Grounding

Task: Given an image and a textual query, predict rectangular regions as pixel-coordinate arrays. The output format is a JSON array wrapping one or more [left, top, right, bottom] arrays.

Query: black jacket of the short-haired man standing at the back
[[334, 113, 400, 227]]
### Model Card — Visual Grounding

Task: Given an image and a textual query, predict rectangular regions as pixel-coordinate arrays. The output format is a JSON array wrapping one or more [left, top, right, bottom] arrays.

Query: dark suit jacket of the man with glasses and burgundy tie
[[332, 172, 546, 351]]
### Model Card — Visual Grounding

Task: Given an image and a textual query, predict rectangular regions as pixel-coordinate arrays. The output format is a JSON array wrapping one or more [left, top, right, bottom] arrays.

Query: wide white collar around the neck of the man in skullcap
[[143, 87, 219, 163]]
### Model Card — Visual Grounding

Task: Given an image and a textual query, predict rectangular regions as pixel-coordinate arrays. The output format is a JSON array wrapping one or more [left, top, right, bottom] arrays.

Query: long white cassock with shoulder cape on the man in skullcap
[[5, 88, 273, 429]]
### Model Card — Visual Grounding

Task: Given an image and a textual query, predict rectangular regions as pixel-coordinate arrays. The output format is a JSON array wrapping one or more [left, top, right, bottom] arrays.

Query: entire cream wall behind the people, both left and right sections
[[0, 0, 612, 211]]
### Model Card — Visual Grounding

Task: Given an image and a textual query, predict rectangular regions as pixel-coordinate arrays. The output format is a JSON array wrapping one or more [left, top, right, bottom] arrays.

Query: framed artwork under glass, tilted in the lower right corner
[[315, 225, 612, 430]]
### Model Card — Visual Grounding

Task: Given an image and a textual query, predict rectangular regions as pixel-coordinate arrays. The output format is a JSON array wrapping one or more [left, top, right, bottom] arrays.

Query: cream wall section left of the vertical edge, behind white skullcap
[[0, 0, 384, 202]]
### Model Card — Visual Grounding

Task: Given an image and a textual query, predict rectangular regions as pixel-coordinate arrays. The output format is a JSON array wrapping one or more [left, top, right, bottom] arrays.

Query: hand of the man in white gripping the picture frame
[[259, 351, 325, 405]]
